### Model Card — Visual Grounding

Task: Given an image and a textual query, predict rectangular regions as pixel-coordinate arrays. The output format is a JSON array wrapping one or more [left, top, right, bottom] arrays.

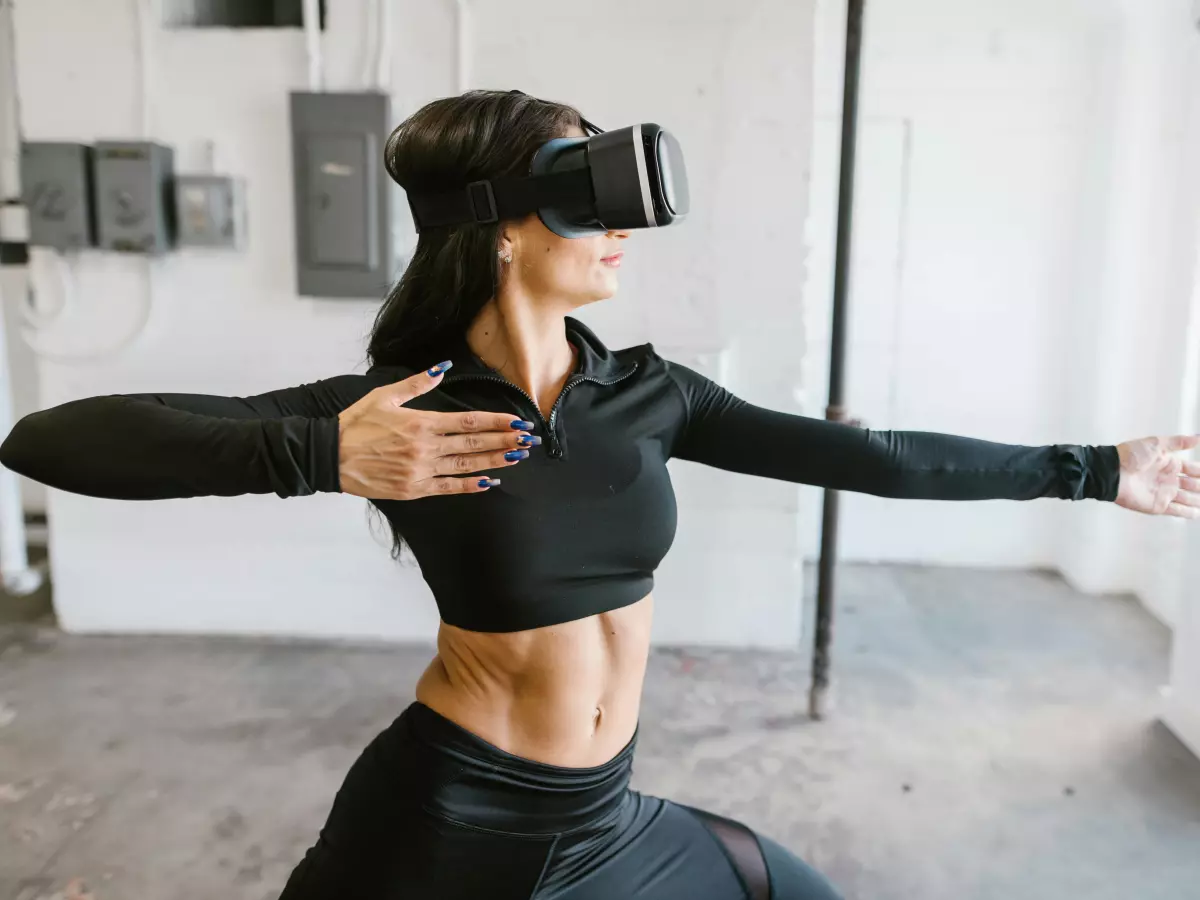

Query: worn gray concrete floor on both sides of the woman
[[0, 566, 1200, 900]]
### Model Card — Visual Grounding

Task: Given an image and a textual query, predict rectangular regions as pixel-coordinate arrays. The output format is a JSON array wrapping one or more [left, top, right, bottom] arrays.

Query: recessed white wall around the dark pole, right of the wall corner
[[803, 0, 1200, 618]]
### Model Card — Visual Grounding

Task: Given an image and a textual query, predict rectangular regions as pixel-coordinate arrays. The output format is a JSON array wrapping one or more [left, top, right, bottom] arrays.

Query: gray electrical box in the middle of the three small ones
[[94, 140, 175, 253]]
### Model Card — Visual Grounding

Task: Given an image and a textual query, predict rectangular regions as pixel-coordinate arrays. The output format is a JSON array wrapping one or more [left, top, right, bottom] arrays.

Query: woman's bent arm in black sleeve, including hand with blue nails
[[0, 364, 540, 500]]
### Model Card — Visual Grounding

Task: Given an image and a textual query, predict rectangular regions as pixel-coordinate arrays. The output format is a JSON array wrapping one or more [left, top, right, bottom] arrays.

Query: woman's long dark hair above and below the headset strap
[[367, 91, 582, 367]]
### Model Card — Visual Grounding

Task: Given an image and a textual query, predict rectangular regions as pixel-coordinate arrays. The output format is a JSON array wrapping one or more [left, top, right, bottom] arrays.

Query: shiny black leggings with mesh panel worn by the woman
[[281, 703, 839, 900]]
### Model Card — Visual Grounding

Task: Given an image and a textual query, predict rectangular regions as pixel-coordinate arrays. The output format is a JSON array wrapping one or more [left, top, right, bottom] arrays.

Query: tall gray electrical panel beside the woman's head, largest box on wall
[[292, 92, 392, 298]]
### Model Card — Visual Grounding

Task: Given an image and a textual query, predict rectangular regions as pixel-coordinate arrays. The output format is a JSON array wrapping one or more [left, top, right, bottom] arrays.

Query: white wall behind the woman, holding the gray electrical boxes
[[17, 0, 812, 646]]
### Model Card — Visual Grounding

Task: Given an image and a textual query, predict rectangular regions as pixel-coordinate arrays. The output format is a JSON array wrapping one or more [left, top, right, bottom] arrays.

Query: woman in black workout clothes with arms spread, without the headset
[[0, 86, 1200, 900]]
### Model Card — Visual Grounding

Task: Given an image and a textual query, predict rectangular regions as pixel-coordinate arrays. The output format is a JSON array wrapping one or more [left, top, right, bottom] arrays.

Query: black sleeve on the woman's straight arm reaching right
[[668, 364, 1120, 500]]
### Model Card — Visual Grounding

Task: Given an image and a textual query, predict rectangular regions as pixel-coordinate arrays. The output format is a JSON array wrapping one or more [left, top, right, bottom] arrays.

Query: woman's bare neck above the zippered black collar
[[467, 294, 575, 410]]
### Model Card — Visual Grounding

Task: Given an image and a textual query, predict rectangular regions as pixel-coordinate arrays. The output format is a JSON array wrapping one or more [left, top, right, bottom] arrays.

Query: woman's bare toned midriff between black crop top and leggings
[[416, 595, 654, 768]]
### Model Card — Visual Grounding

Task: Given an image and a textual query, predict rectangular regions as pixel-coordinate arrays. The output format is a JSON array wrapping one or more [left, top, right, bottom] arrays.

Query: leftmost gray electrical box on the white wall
[[20, 142, 96, 250]]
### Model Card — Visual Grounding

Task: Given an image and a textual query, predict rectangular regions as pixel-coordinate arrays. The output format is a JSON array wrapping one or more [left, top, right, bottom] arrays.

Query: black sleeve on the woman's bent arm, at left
[[0, 376, 382, 500]]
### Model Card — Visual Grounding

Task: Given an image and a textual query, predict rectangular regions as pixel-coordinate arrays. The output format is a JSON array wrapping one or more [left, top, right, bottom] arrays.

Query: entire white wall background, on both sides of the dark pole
[[8, 0, 1200, 646]]
